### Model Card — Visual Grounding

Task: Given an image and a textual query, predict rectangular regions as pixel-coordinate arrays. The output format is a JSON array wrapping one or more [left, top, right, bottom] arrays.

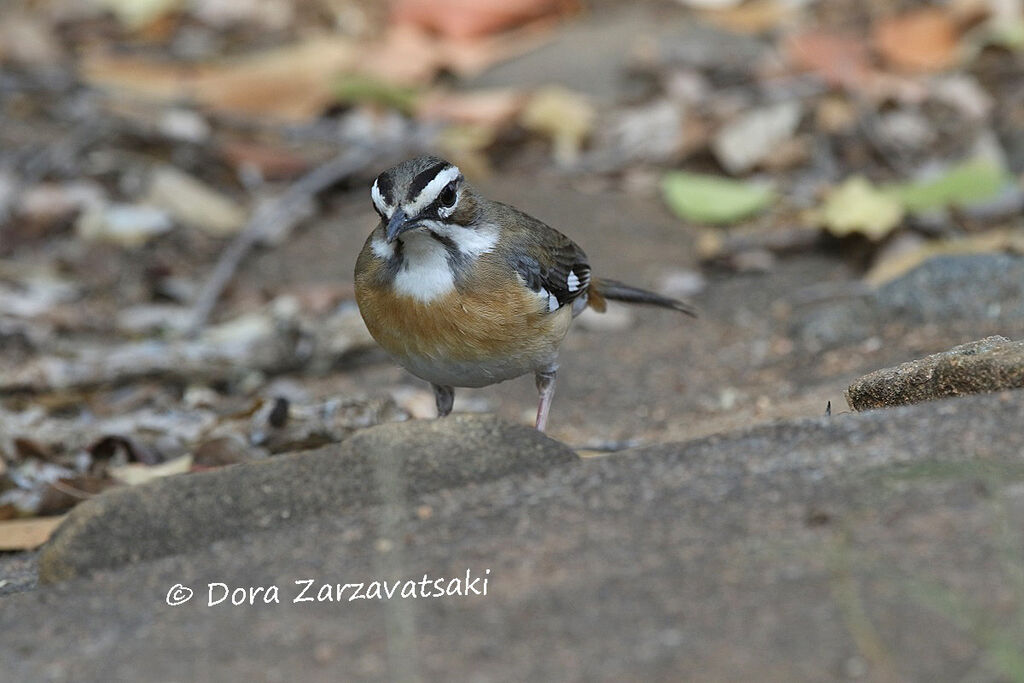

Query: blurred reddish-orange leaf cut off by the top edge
[[391, 0, 578, 38]]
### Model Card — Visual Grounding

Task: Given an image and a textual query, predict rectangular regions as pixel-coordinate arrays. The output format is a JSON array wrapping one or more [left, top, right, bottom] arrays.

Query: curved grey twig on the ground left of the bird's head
[[188, 146, 391, 336]]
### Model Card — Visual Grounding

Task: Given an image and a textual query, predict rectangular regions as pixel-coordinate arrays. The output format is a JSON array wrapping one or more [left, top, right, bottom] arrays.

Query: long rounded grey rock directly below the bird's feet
[[40, 415, 577, 582]]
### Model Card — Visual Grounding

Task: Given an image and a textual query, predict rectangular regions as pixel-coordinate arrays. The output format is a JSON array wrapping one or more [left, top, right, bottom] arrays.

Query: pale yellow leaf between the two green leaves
[[821, 175, 903, 240]]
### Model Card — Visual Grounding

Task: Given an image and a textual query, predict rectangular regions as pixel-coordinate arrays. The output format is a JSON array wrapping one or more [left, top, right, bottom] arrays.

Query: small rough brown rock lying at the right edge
[[846, 337, 1024, 411]]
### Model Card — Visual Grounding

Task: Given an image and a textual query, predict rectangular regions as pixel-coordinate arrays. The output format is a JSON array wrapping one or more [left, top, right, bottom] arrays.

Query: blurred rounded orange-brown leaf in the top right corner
[[872, 7, 959, 72]]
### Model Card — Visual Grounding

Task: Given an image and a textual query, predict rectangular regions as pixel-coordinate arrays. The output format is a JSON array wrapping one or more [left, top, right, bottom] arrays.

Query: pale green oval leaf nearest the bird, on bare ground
[[662, 171, 775, 223]]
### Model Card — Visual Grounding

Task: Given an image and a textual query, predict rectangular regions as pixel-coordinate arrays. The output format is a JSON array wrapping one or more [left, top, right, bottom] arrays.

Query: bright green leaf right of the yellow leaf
[[888, 159, 1009, 213]]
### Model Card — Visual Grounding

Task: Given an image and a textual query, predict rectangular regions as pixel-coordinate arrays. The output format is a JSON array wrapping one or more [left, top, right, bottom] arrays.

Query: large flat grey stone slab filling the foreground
[[0, 392, 1024, 683]]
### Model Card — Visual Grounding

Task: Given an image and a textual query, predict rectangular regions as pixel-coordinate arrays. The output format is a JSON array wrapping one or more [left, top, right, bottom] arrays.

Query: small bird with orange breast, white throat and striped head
[[355, 157, 694, 431]]
